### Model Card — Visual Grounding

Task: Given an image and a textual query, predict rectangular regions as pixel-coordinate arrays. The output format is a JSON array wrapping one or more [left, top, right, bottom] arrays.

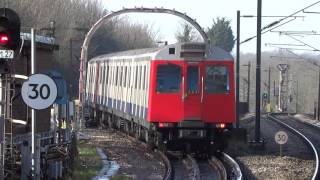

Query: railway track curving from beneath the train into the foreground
[[82, 127, 242, 180]]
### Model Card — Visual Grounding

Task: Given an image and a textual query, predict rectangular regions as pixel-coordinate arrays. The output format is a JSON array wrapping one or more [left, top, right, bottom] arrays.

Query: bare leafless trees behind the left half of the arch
[[0, 0, 155, 96]]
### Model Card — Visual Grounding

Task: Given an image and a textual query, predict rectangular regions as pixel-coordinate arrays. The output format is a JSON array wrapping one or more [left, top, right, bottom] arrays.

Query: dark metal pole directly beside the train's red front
[[236, 11, 240, 128]]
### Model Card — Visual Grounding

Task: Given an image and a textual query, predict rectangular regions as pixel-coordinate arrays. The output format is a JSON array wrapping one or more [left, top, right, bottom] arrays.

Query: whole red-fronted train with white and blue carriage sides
[[85, 43, 235, 153]]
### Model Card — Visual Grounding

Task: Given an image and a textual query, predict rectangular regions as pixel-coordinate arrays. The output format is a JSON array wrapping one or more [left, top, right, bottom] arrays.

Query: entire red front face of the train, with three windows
[[148, 60, 235, 123]]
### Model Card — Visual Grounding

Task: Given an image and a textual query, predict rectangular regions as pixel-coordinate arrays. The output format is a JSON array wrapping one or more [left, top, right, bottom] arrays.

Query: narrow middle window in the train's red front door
[[187, 66, 199, 93]]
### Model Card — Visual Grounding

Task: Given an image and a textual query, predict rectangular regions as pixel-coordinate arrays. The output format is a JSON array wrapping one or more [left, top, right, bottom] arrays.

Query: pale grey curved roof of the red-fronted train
[[90, 42, 233, 62]]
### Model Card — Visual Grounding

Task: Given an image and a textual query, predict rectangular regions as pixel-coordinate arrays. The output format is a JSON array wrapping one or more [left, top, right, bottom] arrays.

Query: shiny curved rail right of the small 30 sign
[[267, 114, 319, 180]]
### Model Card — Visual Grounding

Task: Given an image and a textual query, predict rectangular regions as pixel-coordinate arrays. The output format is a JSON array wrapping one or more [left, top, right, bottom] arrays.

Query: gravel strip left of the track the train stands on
[[80, 129, 165, 180]]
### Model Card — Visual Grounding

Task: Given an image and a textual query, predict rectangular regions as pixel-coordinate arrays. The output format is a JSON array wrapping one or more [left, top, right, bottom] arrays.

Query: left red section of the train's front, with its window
[[148, 60, 183, 122]]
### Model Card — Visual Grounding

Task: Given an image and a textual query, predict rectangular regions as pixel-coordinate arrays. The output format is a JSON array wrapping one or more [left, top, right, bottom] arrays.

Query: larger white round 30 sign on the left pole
[[21, 74, 57, 109]]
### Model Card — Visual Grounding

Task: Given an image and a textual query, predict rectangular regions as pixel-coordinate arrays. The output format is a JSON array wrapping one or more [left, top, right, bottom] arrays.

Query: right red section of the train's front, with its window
[[201, 61, 235, 123]]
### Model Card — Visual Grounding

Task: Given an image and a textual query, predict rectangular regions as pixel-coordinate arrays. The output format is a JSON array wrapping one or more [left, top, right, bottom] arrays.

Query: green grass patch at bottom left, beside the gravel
[[69, 143, 102, 180]]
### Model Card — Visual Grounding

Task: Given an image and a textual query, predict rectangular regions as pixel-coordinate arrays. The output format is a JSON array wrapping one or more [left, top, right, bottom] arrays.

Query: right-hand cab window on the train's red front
[[205, 66, 230, 93]]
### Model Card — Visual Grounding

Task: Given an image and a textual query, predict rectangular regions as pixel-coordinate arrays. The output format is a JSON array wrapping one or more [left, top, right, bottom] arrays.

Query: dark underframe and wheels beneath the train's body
[[87, 107, 232, 154]]
